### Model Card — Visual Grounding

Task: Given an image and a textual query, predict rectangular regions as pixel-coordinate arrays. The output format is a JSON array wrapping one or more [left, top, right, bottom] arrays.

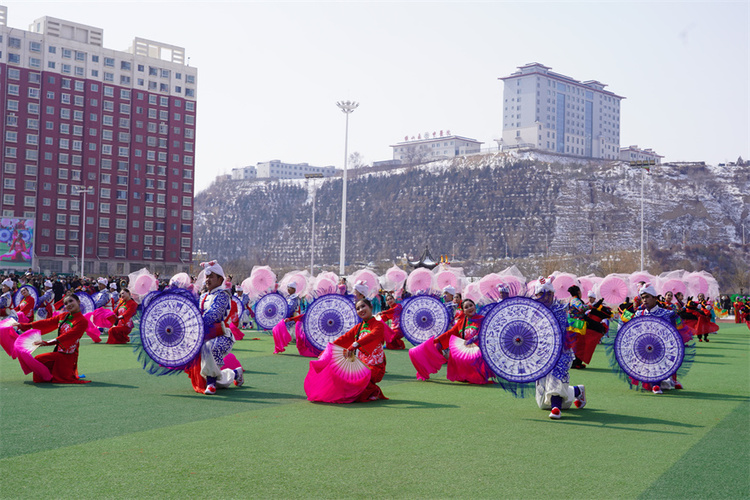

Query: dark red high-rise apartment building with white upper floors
[[0, 7, 197, 275]]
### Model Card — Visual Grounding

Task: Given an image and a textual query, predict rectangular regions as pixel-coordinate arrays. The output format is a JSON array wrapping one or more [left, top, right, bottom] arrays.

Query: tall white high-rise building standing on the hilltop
[[500, 63, 624, 159]]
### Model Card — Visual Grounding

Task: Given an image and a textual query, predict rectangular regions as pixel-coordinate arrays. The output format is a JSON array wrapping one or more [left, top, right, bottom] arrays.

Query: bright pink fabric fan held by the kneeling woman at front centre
[[305, 344, 371, 403]]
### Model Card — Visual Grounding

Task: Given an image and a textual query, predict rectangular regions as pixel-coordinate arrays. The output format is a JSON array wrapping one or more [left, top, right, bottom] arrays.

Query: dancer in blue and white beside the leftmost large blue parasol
[[186, 260, 245, 395]]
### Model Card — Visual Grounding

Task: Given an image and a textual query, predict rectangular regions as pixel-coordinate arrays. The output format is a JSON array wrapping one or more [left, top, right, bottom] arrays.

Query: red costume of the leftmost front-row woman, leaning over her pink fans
[[18, 312, 91, 384]]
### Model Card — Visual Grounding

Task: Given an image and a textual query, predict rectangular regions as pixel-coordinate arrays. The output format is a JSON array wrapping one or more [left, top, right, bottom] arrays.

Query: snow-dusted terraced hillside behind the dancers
[[195, 153, 750, 282]]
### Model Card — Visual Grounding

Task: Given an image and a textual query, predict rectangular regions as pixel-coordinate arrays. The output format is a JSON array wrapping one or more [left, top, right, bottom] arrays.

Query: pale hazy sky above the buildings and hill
[[5, 0, 750, 193]]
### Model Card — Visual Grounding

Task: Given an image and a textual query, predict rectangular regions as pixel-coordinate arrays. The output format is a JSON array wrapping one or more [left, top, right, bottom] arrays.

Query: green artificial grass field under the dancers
[[0, 323, 750, 499]]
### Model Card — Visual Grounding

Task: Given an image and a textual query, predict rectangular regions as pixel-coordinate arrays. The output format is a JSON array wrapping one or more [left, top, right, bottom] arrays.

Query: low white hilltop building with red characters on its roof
[[390, 130, 482, 165]]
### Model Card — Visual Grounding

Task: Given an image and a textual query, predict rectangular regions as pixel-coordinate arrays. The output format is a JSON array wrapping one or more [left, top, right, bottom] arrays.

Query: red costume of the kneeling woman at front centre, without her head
[[333, 318, 388, 401]]
